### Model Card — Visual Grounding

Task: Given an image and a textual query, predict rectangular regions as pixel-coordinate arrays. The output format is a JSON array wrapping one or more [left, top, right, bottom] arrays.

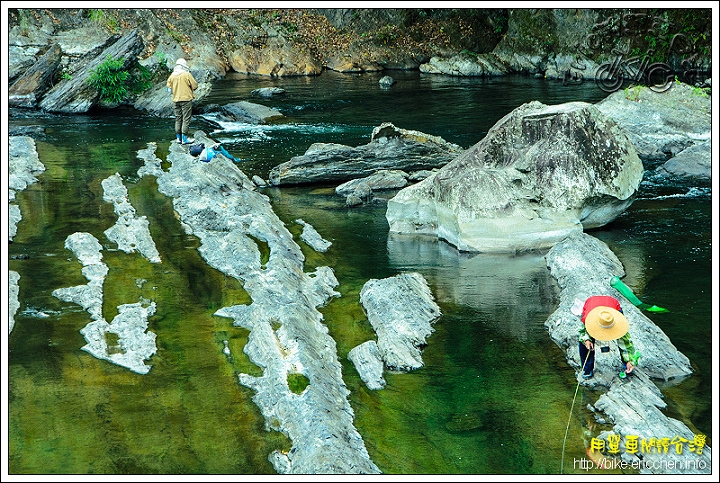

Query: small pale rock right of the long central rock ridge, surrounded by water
[[360, 273, 441, 371]]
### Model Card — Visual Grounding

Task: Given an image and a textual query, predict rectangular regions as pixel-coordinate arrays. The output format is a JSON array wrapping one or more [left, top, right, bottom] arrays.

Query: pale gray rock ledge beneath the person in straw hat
[[545, 233, 710, 474]]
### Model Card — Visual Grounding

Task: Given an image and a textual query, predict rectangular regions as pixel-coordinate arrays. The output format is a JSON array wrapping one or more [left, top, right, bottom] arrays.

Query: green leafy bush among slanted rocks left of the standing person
[[87, 54, 152, 104]]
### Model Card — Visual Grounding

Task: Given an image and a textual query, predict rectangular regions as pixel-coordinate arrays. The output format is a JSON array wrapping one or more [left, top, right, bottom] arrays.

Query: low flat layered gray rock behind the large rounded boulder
[[269, 123, 463, 186]]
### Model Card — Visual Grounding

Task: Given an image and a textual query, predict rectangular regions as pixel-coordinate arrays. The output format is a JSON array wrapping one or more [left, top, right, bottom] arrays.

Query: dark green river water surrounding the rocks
[[3, 72, 714, 475]]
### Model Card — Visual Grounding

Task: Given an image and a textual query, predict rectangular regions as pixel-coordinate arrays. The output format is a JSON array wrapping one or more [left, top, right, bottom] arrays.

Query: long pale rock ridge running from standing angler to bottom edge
[[146, 131, 380, 474]]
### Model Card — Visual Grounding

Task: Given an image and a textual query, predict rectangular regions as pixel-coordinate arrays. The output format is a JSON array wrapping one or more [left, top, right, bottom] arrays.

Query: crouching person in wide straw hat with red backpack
[[578, 295, 639, 379]]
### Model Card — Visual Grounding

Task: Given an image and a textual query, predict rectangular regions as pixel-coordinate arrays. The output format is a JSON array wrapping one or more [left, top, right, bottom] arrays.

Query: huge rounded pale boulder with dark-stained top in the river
[[386, 101, 643, 252]]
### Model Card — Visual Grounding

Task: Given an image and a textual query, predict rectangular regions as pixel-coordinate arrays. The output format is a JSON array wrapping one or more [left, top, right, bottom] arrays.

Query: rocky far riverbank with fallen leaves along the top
[[8, 8, 710, 115]]
